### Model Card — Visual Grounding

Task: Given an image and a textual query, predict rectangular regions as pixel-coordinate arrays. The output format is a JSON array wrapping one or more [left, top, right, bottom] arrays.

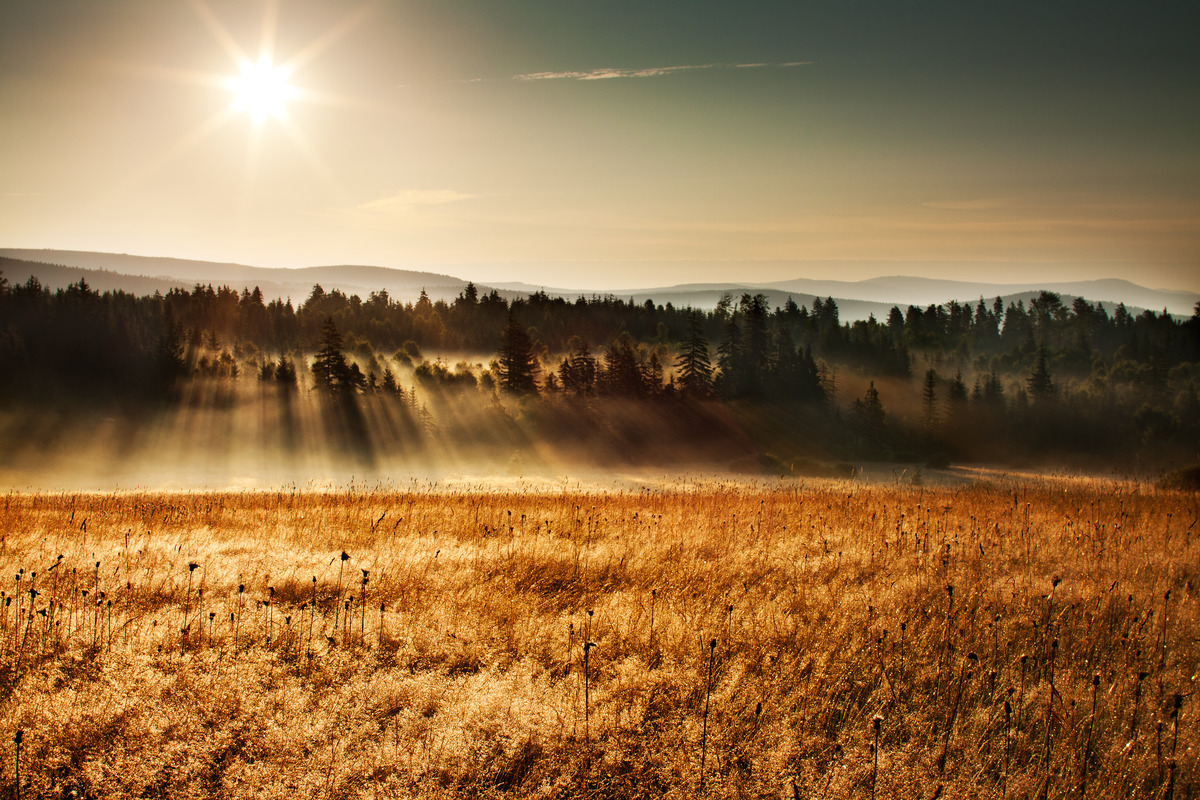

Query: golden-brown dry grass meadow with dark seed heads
[[0, 481, 1200, 798]]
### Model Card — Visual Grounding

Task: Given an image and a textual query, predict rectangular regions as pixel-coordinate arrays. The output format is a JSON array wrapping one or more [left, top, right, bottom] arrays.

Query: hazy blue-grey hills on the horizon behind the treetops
[[0, 249, 1200, 321]]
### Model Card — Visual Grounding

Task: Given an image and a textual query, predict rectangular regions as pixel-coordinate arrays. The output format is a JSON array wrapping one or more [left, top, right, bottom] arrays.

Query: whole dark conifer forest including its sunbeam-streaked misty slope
[[0, 268, 1200, 482]]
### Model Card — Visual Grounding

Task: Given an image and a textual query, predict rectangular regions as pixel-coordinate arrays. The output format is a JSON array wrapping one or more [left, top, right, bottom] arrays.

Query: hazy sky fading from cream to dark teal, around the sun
[[0, 0, 1200, 289]]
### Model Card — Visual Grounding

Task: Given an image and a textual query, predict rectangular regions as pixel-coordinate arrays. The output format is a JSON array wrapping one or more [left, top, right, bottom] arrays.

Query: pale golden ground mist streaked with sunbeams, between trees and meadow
[[0, 368, 755, 491]]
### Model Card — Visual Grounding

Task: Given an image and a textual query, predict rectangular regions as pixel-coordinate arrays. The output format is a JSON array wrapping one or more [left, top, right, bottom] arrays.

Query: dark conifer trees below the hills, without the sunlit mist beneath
[[0, 276, 1200, 458]]
